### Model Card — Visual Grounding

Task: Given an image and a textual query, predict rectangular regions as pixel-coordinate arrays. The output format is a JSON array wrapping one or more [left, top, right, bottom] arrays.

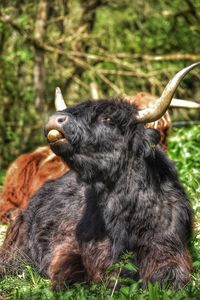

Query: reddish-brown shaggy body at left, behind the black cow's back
[[0, 146, 68, 223]]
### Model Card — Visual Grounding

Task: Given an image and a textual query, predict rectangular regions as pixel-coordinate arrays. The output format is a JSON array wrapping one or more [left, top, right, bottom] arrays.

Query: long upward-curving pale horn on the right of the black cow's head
[[137, 62, 200, 123]]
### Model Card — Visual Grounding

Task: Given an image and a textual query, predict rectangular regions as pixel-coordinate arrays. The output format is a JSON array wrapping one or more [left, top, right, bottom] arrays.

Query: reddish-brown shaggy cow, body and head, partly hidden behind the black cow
[[0, 92, 171, 223]]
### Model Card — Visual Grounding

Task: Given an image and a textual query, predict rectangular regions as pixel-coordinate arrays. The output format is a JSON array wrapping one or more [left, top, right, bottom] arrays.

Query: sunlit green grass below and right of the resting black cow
[[0, 126, 200, 300]]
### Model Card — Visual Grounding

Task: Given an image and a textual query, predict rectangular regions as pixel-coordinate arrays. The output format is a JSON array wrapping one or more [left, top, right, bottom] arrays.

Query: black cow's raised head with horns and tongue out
[[45, 63, 200, 180]]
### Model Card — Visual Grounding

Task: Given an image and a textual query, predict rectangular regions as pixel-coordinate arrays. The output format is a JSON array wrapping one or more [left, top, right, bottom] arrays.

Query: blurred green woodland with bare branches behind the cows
[[0, 0, 200, 168]]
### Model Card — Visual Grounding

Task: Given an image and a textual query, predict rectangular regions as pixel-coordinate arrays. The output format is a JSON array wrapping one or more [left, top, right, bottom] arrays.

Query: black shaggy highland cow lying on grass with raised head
[[0, 63, 199, 289]]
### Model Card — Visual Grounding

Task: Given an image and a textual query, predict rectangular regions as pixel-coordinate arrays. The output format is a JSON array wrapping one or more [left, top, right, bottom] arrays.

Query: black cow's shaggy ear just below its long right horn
[[144, 128, 161, 157]]
